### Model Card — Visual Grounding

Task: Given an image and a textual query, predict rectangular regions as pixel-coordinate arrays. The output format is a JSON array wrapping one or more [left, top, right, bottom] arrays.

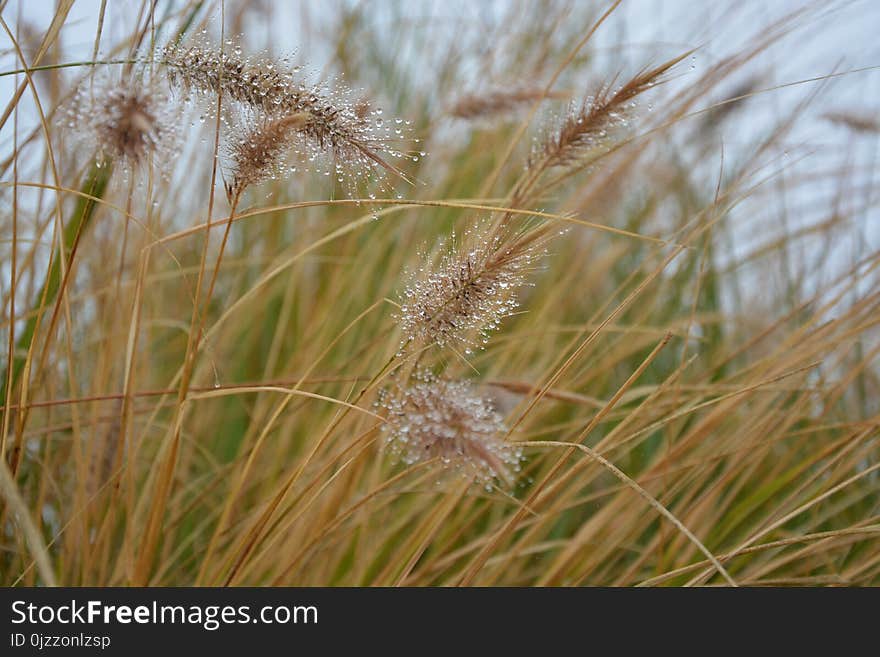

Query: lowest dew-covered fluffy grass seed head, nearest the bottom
[[379, 371, 522, 484]]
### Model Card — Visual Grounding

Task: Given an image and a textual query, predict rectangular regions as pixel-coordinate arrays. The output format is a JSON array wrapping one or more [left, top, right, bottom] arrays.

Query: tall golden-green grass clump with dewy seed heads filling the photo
[[0, 0, 880, 586]]
